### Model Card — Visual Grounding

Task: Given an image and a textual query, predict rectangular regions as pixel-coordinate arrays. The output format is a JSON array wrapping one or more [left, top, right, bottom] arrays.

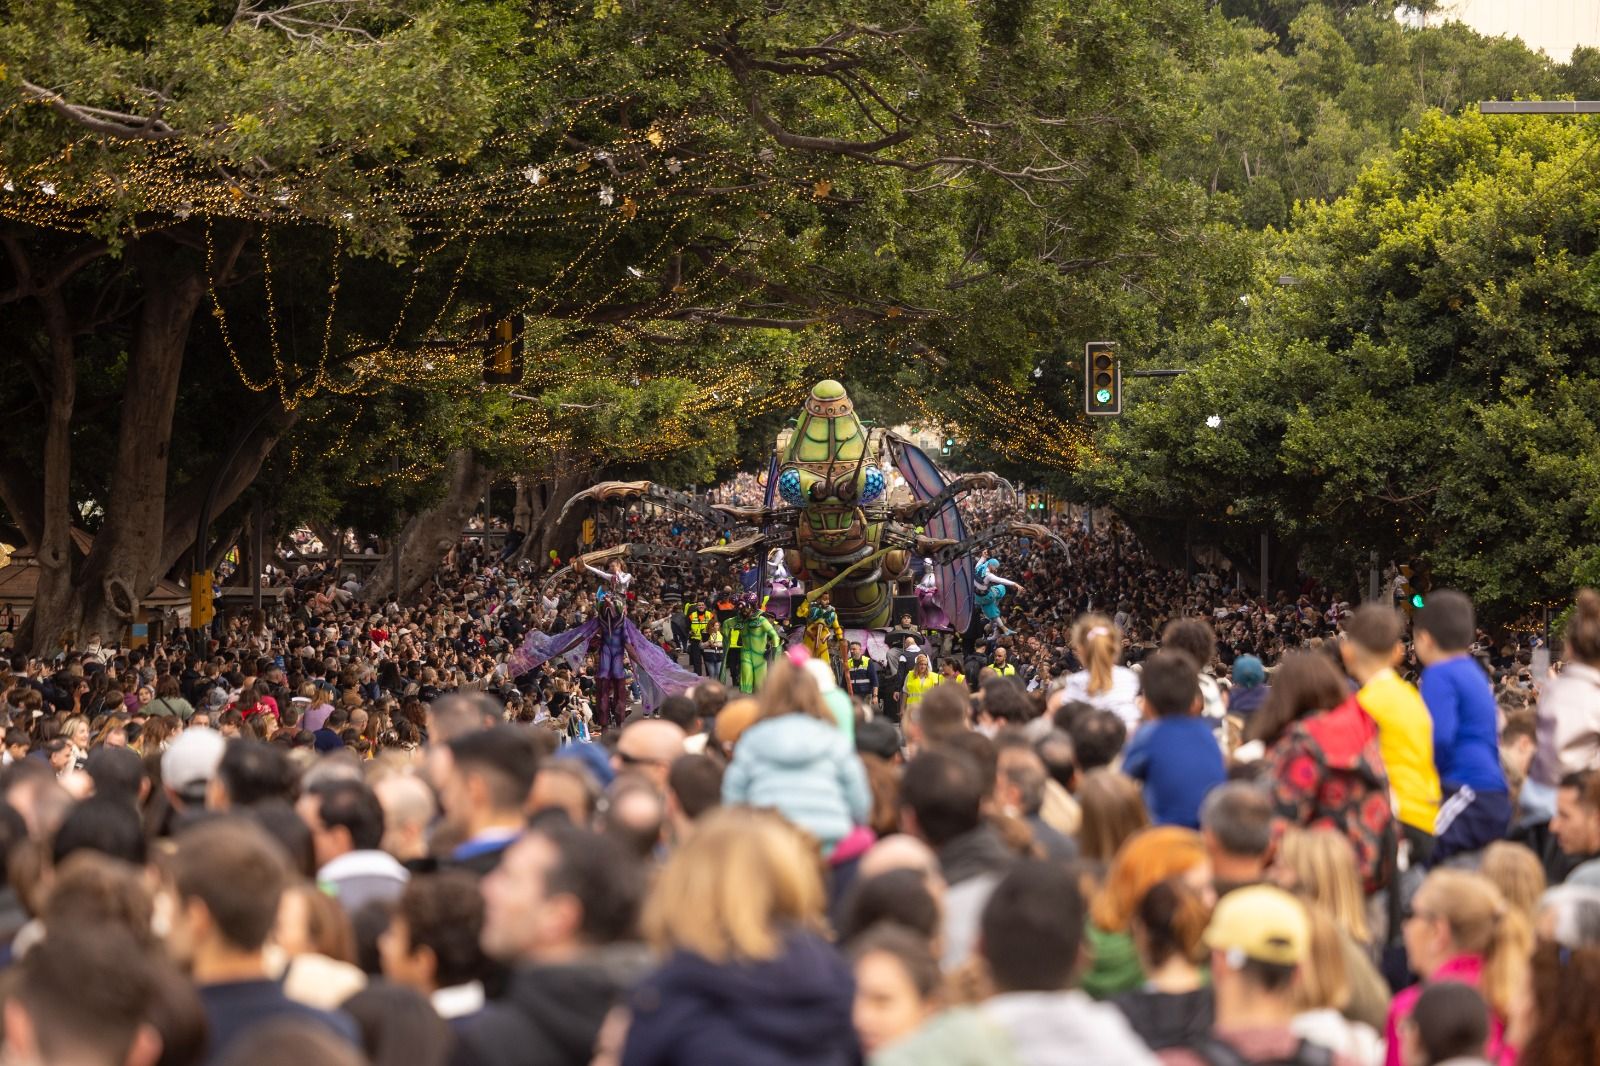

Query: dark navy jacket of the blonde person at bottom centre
[[622, 928, 861, 1066]]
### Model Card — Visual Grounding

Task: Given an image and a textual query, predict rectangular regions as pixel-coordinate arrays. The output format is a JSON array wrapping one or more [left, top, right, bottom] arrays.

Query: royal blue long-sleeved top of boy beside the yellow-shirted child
[[1418, 655, 1506, 792]]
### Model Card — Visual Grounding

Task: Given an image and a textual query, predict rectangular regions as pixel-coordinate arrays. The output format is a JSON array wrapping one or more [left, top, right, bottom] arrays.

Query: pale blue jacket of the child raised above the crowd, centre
[[722, 714, 872, 848]]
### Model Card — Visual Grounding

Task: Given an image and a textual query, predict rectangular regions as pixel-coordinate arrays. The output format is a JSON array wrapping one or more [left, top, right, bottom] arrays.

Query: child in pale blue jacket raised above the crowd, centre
[[722, 650, 872, 855]]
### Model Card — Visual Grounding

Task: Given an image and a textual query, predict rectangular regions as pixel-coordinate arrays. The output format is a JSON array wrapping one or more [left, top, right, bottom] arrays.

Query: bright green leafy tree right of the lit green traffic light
[[1083, 112, 1600, 611]]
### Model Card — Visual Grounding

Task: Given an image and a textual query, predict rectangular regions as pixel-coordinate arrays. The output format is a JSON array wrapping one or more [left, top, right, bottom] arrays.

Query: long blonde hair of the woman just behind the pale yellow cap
[[1267, 829, 1389, 1031]]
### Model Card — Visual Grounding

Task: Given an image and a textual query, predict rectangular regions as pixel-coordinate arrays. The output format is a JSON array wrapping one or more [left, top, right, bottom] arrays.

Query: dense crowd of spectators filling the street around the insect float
[[0, 487, 1600, 1066]]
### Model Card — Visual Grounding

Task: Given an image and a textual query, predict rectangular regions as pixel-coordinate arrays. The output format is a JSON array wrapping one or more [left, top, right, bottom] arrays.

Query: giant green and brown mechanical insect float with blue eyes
[[518, 379, 1066, 703]]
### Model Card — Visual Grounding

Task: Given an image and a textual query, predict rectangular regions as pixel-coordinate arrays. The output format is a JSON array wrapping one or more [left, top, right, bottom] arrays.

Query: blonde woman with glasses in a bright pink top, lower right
[[1384, 869, 1533, 1066]]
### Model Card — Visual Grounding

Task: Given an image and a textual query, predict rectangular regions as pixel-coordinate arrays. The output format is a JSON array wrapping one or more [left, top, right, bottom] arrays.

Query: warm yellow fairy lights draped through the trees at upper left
[[0, 19, 1062, 479]]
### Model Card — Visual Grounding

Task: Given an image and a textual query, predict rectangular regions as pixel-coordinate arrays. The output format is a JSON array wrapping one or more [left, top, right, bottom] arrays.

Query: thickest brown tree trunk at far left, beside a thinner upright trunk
[[77, 256, 205, 640]]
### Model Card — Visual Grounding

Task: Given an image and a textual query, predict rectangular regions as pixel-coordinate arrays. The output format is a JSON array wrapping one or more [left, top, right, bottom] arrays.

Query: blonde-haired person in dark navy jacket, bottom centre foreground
[[622, 806, 861, 1066]]
